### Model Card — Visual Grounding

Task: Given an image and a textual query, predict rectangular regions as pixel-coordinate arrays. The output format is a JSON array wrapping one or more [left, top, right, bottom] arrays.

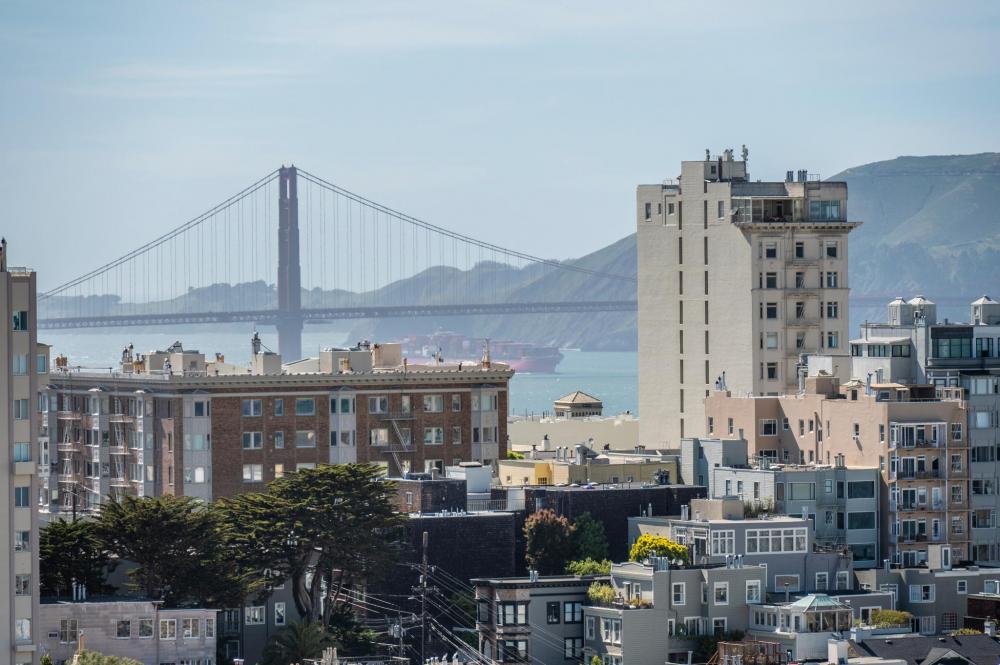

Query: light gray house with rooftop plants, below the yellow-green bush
[[584, 559, 767, 665]]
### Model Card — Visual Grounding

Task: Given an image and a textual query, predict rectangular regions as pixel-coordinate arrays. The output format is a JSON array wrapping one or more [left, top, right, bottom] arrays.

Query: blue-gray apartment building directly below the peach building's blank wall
[[708, 463, 882, 568]]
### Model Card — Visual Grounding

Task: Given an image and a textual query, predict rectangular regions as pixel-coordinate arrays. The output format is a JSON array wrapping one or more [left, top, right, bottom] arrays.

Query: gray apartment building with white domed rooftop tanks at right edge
[[850, 296, 1000, 563]]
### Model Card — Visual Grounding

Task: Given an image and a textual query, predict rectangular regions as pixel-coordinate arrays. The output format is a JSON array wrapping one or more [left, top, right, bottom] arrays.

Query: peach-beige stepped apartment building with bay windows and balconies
[[705, 376, 970, 566]]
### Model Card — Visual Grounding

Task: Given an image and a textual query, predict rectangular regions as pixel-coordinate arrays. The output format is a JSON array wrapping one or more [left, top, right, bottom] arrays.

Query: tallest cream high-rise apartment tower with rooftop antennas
[[636, 148, 858, 446]]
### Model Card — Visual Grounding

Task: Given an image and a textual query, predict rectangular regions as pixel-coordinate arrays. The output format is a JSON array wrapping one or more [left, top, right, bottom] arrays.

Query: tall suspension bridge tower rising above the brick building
[[277, 166, 302, 362]]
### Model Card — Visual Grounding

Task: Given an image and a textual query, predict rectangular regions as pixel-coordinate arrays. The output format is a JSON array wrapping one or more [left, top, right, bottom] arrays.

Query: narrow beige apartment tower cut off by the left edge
[[0, 241, 40, 665]]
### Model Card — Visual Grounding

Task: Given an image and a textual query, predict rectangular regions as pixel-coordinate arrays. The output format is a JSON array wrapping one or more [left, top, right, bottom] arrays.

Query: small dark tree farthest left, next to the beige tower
[[38, 518, 109, 596]]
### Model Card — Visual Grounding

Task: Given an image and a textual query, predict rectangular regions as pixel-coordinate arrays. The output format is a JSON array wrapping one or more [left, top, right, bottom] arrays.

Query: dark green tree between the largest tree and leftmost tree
[[95, 495, 245, 607]]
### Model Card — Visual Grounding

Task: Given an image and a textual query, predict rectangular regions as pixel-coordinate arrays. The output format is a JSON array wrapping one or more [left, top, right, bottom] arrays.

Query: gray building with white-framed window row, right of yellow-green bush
[[629, 502, 853, 593]]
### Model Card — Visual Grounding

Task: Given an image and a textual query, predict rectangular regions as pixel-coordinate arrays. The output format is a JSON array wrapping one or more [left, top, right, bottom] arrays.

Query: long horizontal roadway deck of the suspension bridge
[[38, 300, 637, 330]]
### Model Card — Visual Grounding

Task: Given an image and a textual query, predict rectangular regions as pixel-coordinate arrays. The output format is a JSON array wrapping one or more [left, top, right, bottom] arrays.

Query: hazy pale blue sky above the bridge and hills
[[0, 0, 1000, 290]]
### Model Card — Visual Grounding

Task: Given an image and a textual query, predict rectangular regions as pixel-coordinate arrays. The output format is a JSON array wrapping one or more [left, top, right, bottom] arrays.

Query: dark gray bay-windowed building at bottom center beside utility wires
[[472, 575, 608, 665]]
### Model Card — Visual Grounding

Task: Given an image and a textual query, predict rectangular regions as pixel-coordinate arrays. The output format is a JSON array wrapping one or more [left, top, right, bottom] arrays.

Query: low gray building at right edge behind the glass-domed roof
[[855, 544, 1000, 635]]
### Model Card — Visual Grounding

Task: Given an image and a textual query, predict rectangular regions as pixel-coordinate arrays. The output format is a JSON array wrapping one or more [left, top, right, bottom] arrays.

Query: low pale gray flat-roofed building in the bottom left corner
[[39, 598, 217, 665]]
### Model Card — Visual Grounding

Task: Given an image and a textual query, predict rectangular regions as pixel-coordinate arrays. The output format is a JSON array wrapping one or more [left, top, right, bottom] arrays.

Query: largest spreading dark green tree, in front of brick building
[[218, 464, 403, 626]]
